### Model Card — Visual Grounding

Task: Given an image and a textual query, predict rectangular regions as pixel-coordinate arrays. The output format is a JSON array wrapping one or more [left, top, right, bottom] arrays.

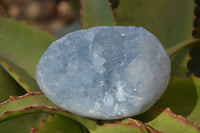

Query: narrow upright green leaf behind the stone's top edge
[[80, 0, 115, 29]]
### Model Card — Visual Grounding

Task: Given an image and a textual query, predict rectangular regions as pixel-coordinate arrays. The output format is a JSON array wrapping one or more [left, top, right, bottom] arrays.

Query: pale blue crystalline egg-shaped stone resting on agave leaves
[[36, 26, 171, 119]]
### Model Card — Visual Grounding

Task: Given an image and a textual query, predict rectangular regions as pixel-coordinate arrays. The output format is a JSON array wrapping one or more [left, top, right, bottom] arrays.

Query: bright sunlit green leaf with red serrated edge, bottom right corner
[[146, 108, 200, 133]]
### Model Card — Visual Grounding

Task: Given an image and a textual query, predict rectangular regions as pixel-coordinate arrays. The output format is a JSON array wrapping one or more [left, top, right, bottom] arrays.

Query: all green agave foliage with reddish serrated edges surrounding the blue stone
[[0, 0, 200, 133]]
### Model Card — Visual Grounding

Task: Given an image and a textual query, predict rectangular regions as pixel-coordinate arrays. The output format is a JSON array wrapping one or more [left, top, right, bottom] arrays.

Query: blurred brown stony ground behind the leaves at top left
[[0, 0, 75, 34]]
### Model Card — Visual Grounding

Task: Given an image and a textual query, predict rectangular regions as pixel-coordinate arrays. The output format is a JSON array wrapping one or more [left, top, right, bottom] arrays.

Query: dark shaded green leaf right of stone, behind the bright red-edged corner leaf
[[137, 76, 200, 126]]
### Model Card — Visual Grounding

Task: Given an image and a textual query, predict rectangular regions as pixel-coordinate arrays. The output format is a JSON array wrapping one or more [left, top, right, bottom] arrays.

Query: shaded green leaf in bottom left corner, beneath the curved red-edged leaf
[[0, 113, 48, 133]]
